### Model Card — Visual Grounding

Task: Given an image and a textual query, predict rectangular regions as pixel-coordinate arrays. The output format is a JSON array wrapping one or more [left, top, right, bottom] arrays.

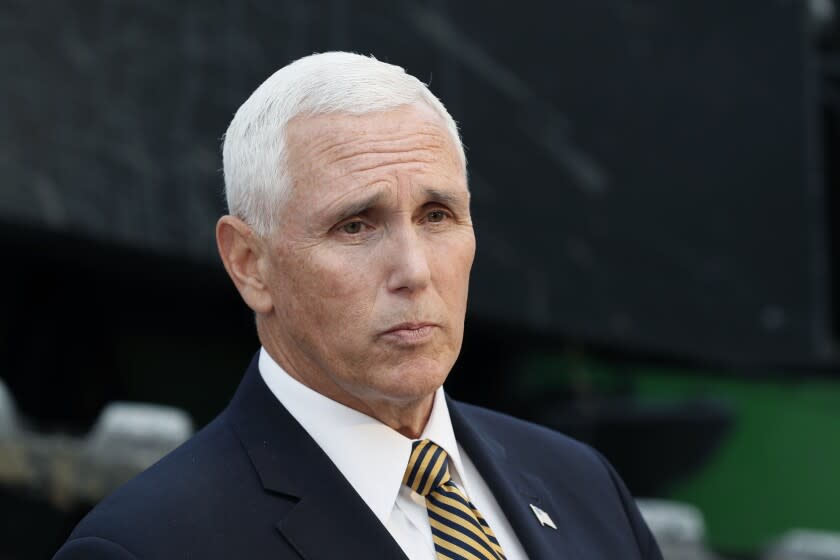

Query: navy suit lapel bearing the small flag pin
[[447, 397, 578, 558]]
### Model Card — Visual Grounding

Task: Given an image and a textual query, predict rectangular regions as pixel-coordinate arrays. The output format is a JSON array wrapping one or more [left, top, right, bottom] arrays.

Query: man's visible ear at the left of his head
[[216, 216, 274, 313]]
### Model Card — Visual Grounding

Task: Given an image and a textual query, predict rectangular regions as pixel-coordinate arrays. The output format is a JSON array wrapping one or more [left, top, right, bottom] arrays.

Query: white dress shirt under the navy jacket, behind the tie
[[259, 348, 527, 560]]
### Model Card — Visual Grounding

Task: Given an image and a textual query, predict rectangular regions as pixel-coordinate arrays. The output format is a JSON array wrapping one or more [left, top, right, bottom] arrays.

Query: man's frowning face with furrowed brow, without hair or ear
[[262, 105, 475, 412]]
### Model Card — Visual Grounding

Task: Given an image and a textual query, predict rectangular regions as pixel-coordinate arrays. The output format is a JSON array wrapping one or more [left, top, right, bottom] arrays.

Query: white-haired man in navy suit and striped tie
[[56, 53, 660, 560]]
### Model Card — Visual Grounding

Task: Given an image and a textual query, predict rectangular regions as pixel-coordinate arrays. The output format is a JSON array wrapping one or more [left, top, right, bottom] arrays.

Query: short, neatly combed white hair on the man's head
[[222, 52, 466, 236]]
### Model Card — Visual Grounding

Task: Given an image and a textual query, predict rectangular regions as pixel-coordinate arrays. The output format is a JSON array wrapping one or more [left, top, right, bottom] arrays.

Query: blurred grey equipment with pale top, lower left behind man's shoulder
[[0, 380, 193, 560]]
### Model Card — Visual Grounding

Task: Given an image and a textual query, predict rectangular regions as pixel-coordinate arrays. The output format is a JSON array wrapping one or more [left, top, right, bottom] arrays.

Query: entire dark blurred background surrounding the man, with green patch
[[0, 0, 840, 560]]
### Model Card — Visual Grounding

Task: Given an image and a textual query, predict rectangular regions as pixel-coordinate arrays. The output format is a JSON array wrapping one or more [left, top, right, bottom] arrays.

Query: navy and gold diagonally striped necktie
[[403, 439, 505, 560]]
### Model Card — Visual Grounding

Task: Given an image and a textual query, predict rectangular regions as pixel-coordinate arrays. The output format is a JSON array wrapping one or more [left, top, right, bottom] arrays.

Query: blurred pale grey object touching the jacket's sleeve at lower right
[[636, 499, 717, 560]]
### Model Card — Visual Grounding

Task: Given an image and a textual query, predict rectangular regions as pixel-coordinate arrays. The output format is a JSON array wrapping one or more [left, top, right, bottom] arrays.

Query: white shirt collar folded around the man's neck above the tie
[[259, 348, 464, 524]]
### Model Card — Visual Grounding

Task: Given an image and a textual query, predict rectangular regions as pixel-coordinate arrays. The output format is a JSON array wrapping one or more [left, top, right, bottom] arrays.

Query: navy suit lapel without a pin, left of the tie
[[223, 358, 405, 560]]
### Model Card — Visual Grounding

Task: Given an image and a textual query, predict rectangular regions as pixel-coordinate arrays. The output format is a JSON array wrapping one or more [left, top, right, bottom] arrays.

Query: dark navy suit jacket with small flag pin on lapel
[[55, 358, 661, 560]]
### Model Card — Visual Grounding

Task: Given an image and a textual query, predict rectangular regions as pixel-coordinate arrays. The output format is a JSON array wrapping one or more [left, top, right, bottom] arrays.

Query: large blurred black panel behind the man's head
[[0, 0, 830, 363]]
